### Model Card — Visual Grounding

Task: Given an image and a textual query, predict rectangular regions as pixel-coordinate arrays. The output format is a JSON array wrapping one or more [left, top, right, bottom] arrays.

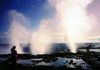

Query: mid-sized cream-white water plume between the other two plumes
[[31, 20, 53, 55]]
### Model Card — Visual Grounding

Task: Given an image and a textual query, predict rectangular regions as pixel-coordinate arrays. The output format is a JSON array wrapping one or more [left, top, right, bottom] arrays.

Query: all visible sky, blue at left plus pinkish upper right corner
[[0, 0, 100, 43]]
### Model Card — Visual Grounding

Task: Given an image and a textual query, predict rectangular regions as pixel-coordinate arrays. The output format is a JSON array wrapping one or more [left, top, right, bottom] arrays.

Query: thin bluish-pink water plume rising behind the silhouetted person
[[8, 10, 28, 53]]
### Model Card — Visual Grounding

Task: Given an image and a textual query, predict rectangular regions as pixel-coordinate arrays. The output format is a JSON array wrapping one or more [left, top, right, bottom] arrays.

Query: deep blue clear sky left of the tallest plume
[[0, 0, 53, 43]]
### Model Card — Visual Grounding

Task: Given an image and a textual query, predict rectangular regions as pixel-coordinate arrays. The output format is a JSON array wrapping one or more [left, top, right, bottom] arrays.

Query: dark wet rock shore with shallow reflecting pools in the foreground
[[0, 52, 100, 70]]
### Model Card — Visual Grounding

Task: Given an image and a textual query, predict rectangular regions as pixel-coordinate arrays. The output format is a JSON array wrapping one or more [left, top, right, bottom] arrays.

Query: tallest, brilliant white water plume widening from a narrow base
[[49, 0, 92, 53]]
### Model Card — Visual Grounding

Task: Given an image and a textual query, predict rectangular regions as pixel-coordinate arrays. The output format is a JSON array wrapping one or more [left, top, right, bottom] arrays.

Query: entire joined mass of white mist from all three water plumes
[[9, 0, 97, 55]]
